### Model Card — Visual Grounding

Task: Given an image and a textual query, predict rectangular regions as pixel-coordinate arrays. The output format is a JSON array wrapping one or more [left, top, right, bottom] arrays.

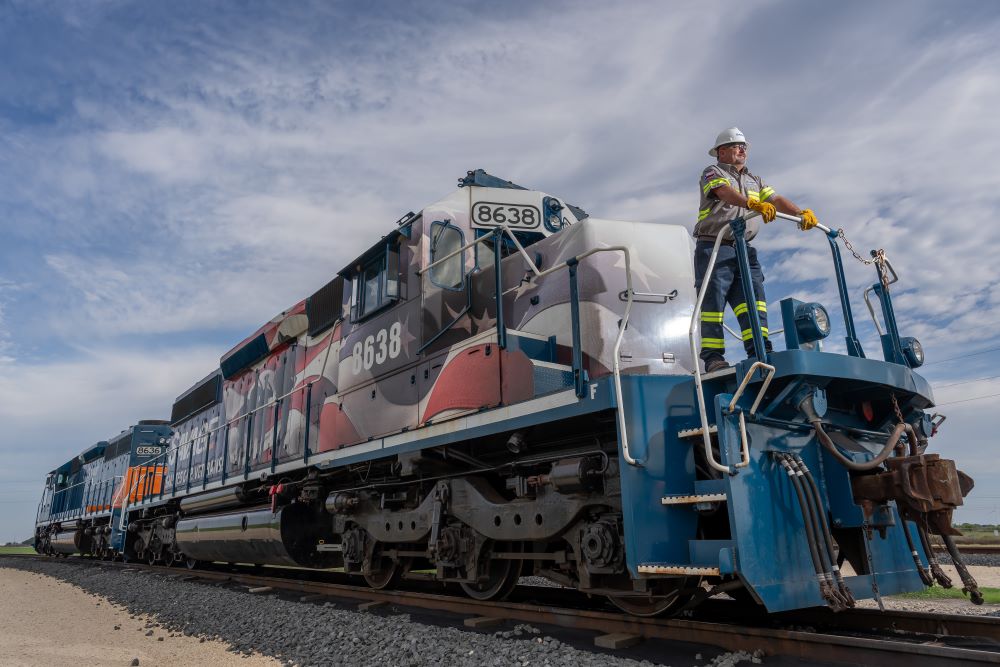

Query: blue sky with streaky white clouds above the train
[[0, 0, 1000, 543]]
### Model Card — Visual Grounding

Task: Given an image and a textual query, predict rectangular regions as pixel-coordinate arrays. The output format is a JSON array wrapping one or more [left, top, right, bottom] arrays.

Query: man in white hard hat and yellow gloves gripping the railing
[[694, 127, 818, 373]]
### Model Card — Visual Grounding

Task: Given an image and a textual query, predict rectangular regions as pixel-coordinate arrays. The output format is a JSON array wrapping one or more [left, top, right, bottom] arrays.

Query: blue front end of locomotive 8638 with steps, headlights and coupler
[[621, 219, 982, 612]]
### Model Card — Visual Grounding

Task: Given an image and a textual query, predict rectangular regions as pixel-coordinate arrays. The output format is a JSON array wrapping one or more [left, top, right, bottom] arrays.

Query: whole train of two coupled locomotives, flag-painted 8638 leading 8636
[[35, 170, 981, 615]]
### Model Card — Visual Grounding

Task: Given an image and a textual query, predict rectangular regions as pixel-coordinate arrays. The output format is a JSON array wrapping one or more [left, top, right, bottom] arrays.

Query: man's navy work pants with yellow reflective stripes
[[694, 241, 771, 363]]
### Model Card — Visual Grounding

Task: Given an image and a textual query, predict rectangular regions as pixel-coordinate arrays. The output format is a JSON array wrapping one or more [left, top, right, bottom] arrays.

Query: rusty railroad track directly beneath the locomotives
[[11, 556, 1000, 667]]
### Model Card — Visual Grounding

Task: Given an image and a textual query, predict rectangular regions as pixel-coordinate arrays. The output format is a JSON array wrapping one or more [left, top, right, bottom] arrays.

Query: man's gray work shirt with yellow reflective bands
[[694, 162, 774, 241]]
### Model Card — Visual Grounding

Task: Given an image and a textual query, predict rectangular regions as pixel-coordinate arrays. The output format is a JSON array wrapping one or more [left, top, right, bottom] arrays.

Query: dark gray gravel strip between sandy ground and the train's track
[[0, 557, 748, 667]]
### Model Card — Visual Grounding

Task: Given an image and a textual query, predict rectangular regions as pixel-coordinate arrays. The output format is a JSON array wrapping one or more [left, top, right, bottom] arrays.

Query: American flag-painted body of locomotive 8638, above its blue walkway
[[166, 187, 693, 491]]
